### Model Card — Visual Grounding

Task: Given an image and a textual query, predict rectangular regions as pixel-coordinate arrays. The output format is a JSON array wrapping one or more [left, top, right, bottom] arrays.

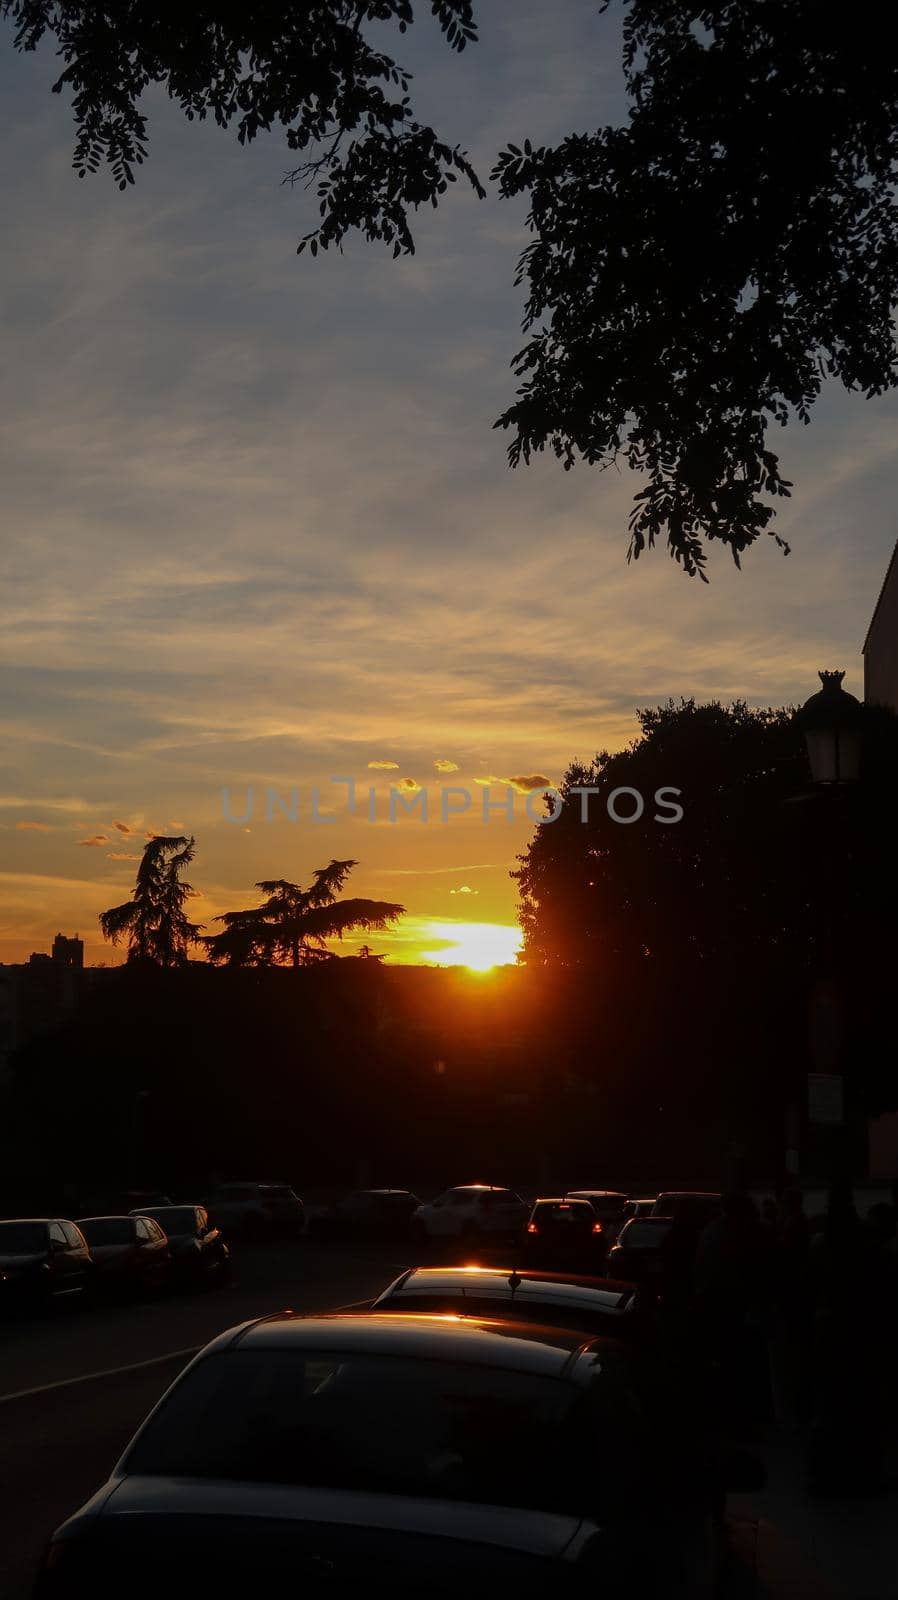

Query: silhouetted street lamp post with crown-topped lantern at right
[[792, 672, 863, 1179]]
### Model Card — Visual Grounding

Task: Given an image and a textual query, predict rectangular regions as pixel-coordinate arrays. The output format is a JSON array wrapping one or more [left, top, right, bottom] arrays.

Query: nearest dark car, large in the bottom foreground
[[35, 1314, 744, 1600]]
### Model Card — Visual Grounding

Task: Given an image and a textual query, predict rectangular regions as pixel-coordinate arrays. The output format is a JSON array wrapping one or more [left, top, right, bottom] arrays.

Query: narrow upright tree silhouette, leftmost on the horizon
[[99, 835, 202, 966]]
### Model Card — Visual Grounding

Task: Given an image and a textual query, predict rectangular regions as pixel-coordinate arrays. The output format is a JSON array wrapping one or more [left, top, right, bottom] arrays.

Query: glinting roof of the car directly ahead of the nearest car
[[374, 1267, 634, 1315]]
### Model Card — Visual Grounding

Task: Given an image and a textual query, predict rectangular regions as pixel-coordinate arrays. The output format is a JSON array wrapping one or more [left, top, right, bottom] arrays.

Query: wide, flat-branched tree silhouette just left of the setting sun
[[203, 861, 405, 966]]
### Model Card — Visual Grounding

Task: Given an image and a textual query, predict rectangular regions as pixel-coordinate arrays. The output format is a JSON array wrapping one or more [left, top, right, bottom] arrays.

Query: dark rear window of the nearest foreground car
[[125, 1349, 616, 1510]]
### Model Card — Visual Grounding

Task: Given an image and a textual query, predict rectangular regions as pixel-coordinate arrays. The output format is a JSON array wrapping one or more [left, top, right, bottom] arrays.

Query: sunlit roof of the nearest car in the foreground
[[203, 1312, 602, 1378]]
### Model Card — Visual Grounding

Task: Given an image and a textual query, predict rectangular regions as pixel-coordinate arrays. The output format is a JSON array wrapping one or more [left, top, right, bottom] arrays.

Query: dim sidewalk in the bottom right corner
[[728, 1432, 898, 1600]]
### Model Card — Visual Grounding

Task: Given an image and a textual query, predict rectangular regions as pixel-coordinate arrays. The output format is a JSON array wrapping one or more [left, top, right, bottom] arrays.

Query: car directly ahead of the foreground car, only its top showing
[[371, 1267, 639, 1338]]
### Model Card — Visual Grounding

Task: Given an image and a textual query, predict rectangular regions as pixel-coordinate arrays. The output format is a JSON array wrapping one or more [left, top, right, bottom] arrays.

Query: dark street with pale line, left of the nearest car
[[0, 1240, 398, 1600]]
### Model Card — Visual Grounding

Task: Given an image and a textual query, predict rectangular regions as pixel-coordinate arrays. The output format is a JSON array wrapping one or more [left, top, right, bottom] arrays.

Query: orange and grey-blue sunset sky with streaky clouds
[[0, 0, 898, 962]]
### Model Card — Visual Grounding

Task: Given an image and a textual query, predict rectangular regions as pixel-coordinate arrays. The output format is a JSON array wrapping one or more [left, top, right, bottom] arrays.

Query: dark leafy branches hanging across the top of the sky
[[7, 0, 898, 578]]
